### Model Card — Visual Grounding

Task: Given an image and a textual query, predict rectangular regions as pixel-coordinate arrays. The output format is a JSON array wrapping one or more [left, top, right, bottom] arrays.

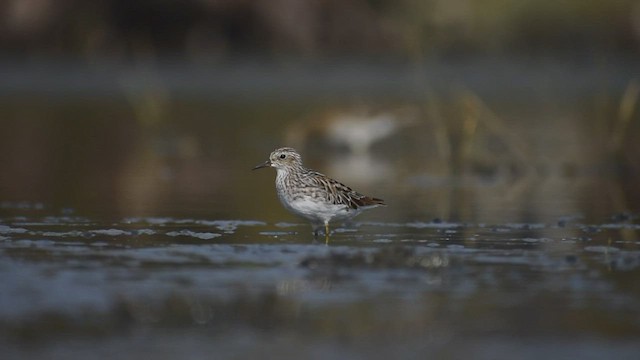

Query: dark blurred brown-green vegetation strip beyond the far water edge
[[0, 0, 640, 62]]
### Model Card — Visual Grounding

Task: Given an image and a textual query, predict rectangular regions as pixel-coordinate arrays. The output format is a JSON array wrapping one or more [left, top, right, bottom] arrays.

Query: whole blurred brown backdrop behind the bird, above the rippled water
[[0, 0, 640, 221]]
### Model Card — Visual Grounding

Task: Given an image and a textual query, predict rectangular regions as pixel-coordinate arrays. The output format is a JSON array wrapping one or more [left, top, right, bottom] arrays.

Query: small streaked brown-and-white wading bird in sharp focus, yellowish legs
[[253, 147, 386, 242]]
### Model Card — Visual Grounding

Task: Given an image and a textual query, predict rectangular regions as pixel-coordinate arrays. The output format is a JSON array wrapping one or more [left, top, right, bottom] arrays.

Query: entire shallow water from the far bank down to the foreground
[[0, 60, 640, 359]]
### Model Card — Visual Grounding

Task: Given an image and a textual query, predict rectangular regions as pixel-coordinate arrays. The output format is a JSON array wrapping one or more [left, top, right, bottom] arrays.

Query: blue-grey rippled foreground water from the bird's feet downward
[[0, 206, 640, 359]]
